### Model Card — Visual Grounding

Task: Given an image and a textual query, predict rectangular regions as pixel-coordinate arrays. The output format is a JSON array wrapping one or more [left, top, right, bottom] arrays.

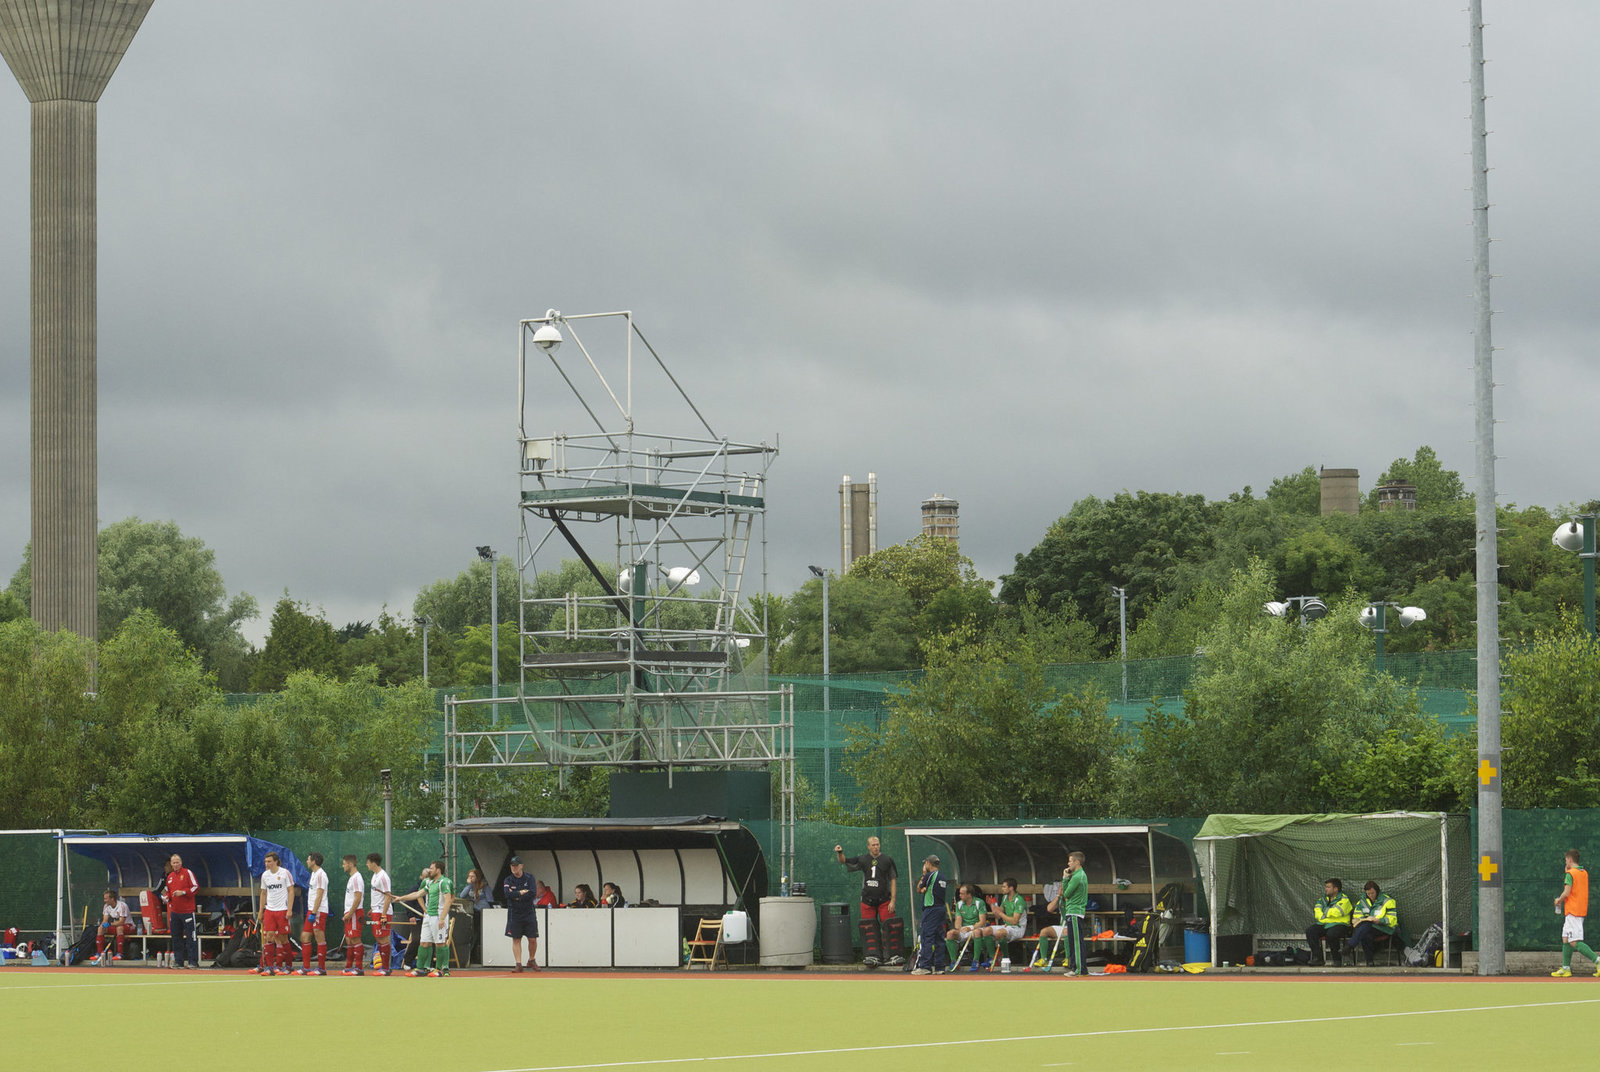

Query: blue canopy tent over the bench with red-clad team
[[56, 834, 310, 950]]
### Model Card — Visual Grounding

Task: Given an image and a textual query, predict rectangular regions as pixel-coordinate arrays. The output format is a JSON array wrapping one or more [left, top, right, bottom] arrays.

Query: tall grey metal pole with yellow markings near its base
[[1465, 0, 1506, 976]]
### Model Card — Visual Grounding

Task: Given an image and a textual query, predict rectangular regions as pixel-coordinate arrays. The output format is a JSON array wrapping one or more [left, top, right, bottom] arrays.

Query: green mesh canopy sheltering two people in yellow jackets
[[1194, 811, 1474, 965]]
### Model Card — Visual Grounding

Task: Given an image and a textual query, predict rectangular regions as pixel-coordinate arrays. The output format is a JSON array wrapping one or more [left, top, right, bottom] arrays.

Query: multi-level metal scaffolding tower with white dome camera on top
[[445, 310, 795, 869]]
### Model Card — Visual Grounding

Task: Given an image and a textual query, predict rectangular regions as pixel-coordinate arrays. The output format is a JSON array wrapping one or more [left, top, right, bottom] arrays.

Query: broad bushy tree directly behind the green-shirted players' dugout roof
[[845, 629, 1118, 822]]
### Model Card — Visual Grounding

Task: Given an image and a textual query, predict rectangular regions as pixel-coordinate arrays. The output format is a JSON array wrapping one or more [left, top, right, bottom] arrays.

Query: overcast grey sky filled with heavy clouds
[[0, 0, 1600, 640]]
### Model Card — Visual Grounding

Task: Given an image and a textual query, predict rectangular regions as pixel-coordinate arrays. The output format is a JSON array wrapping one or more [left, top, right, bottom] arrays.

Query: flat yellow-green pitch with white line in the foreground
[[0, 968, 1600, 1072]]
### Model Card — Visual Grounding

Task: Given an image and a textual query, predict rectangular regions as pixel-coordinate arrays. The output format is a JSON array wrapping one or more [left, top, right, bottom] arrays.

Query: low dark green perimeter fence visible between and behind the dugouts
[[0, 810, 1600, 950]]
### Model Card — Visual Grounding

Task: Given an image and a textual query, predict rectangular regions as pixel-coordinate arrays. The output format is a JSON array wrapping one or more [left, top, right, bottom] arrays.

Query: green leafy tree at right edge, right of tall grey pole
[[1501, 618, 1600, 808]]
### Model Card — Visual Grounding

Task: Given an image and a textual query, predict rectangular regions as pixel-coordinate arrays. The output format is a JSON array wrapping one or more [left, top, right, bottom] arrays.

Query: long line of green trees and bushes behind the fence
[[0, 446, 1600, 827]]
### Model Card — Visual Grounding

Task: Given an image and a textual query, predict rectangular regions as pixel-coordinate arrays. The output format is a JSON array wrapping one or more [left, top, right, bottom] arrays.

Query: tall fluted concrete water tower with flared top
[[0, 0, 150, 640]]
